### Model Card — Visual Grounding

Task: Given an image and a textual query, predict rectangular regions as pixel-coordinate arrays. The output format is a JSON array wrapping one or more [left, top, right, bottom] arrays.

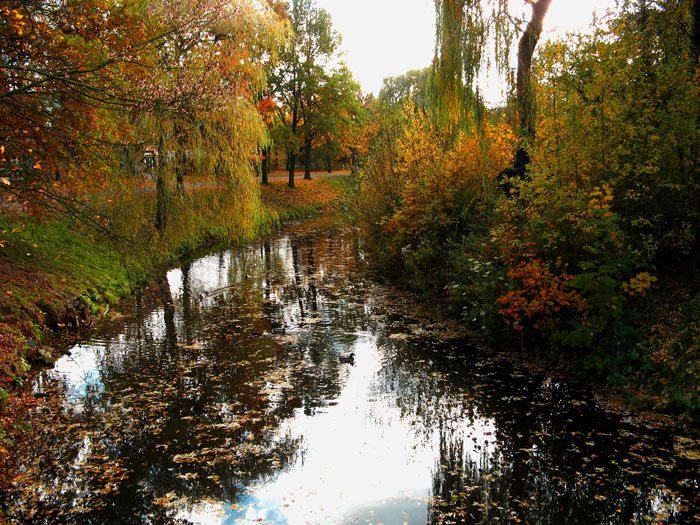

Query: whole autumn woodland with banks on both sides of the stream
[[0, 0, 700, 450]]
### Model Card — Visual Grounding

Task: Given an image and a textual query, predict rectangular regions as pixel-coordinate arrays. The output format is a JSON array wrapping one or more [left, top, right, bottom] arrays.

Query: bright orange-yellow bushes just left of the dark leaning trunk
[[363, 103, 515, 246]]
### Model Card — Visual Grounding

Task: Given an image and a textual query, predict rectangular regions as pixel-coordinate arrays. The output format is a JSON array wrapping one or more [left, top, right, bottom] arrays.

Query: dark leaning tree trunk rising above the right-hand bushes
[[513, 0, 552, 178]]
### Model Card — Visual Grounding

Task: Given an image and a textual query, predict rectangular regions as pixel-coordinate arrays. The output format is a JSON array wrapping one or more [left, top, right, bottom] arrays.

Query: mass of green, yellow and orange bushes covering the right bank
[[358, 2, 700, 388]]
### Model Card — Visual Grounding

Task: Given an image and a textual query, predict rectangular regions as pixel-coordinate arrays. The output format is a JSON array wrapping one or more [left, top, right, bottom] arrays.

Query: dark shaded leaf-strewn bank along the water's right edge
[[376, 245, 700, 430]]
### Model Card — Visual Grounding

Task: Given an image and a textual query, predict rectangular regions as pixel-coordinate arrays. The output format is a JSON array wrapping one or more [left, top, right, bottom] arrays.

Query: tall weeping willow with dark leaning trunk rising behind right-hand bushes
[[432, 0, 552, 174]]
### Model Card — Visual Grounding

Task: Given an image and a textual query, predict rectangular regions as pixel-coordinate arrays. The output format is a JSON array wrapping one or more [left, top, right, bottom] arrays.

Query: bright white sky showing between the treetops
[[316, 0, 615, 104]]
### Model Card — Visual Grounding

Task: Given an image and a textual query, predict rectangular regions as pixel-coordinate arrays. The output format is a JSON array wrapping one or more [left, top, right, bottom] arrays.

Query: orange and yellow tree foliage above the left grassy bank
[[0, 0, 286, 226]]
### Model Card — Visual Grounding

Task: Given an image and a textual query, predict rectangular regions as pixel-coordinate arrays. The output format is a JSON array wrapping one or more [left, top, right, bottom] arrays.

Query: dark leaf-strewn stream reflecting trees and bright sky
[[4, 215, 698, 525]]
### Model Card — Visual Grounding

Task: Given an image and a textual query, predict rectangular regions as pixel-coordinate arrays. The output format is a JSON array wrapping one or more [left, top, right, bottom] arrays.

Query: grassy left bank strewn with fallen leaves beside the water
[[0, 177, 352, 456]]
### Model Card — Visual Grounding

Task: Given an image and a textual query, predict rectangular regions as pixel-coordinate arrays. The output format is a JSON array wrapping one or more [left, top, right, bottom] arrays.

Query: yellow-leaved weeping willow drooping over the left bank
[[137, 0, 286, 231]]
